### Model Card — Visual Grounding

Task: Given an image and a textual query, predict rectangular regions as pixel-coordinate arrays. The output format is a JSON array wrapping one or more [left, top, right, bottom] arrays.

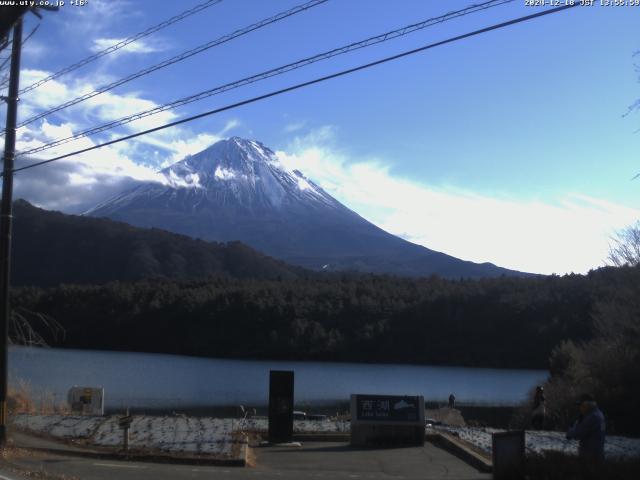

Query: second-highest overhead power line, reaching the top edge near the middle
[[18, 0, 328, 127]]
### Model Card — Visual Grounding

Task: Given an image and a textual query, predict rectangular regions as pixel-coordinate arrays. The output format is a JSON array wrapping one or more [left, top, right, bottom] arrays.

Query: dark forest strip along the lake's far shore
[[13, 267, 640, 368]]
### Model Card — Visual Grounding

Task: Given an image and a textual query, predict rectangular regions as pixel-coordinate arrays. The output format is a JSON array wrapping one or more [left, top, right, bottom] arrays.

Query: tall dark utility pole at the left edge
[[0, 15, 22, 449]]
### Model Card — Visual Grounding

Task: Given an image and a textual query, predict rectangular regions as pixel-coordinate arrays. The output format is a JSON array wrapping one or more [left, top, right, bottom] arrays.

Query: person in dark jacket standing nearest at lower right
[[567, 394, 606, 465]]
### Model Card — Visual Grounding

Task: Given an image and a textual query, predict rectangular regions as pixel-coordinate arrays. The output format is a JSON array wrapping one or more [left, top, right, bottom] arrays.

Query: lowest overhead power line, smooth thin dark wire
[[13, 2, 580, 173]]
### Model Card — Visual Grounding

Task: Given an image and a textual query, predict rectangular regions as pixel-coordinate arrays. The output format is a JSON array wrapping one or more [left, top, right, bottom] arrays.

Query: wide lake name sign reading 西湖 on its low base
[[351, 395, 424, 446]]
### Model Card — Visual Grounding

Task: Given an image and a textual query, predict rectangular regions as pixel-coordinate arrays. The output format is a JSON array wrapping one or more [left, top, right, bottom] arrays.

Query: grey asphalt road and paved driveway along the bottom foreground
[[0, 442, 491, 480]]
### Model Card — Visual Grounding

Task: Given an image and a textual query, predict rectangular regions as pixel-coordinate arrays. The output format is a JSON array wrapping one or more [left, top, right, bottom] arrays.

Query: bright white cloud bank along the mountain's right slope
[[278, 128, 640, 273]]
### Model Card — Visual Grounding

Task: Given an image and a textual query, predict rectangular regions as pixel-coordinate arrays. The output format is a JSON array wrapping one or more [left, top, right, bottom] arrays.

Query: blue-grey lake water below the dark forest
[[9, 347, 548, 409]]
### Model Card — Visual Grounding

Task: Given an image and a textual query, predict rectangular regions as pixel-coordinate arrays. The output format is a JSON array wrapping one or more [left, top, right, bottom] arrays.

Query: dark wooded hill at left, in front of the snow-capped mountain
[[11, 200, 305, 286]]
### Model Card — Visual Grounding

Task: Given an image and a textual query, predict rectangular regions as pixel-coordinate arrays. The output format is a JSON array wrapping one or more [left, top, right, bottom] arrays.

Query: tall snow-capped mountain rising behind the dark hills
[[85, 137, 525, 278]]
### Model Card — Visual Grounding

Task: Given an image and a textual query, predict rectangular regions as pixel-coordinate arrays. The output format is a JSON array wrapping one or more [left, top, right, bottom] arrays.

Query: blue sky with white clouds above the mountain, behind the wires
[[3, 0, 640, 273]]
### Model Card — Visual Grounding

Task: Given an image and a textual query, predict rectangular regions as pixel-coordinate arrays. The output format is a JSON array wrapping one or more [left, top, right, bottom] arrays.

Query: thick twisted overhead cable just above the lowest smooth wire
[[20, 0, 514, 156]]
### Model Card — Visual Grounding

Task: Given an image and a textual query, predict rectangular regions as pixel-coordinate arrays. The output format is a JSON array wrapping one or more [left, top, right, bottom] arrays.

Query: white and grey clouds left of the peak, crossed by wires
[[8, 70, 240, 212]]
